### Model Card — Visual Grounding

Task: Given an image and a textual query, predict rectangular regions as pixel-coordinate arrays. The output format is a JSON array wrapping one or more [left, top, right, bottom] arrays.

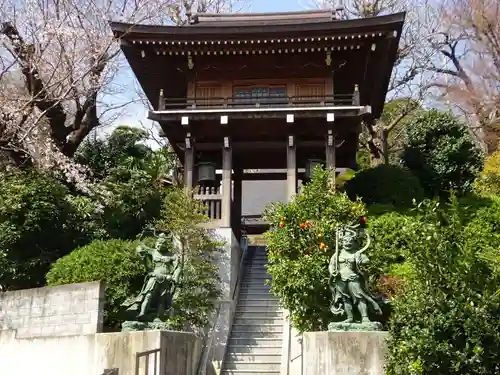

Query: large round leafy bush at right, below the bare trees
[[402, 110, 483, 196]]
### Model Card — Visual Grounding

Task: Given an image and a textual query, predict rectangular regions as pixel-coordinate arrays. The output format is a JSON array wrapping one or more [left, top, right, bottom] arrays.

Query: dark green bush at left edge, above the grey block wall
[[0, 171, 88, 290]]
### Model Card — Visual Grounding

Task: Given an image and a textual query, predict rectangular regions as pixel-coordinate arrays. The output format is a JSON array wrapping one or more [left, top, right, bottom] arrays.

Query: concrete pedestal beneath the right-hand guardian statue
[[303, 331, 388, 375]]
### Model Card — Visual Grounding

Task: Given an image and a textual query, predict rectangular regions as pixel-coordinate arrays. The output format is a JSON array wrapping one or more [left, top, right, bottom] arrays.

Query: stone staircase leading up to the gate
[[222, 246, 283, 375]]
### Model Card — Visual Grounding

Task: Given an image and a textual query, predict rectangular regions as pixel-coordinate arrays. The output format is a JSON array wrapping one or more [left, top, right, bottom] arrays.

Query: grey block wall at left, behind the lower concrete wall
[[0, 282, 104, 338]]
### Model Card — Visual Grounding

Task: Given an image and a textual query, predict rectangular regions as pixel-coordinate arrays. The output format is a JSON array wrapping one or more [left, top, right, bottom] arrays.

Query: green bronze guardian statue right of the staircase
[[328, 218, 382, 330]]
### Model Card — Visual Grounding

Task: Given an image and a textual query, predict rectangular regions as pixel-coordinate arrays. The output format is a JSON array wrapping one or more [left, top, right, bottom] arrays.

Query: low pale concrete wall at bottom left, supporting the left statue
[[0, 331, 201, 375]]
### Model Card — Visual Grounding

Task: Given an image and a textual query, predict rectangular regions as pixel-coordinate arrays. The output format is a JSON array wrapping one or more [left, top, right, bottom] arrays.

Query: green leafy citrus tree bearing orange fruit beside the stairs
[[264, 169, 365, 331]]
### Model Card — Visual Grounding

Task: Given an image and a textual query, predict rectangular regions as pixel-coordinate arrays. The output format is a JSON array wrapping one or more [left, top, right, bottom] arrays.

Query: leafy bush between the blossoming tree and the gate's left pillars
[[73, 126, 174, 239]]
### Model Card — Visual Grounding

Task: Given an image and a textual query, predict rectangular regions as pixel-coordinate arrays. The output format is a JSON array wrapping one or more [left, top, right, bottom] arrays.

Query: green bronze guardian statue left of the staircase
[[122, 233, 182, 330]]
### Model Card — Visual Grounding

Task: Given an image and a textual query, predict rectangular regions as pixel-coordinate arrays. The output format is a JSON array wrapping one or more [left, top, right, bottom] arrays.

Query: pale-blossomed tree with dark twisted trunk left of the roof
[[0, 0, 244, 188]]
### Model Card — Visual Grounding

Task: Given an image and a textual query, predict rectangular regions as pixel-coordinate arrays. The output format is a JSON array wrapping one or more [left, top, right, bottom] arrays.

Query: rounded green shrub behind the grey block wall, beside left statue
[[47, 239, 146, 328]]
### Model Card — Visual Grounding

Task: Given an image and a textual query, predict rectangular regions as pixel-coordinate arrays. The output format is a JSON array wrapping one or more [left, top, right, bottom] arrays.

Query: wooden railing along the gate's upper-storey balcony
[[158, 91, 360, 111]]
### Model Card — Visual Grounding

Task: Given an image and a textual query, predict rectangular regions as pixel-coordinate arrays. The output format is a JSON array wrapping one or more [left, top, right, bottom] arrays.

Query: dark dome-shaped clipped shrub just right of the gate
[[346, 165, 424, 207]]
